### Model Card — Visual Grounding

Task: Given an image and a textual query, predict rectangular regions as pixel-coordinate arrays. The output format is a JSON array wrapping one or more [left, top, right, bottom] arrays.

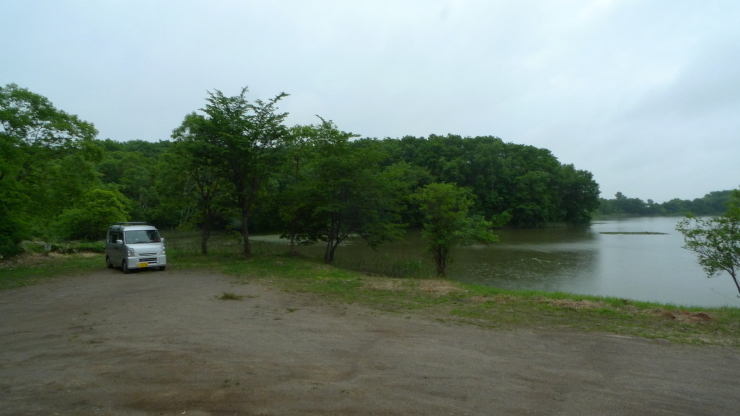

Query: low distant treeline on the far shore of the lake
[[598, 190, 732, 215]]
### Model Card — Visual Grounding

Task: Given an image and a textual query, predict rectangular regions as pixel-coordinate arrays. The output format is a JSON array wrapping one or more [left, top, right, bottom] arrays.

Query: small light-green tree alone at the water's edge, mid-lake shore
[[413, 183, 498, 276]]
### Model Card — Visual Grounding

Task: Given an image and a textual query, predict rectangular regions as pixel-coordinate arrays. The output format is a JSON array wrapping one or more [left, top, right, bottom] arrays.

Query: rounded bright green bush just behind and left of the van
[[58, 189, 126, 241]]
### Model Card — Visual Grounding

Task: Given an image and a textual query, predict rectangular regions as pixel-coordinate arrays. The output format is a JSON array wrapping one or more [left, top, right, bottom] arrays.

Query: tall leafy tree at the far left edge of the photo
[[0, 84, 100, 255]]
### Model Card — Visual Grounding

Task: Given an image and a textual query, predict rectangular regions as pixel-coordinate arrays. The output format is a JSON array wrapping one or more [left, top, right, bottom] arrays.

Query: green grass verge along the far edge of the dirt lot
[[0, 250, 740, 347]]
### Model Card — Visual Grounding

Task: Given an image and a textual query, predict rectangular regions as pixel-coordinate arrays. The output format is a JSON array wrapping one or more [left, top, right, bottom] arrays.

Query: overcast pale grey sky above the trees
[[0, 0, 740, 202]]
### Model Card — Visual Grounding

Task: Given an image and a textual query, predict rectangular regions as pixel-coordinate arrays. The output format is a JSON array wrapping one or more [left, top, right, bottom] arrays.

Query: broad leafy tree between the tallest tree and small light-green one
[[294, 119, 405, 263]]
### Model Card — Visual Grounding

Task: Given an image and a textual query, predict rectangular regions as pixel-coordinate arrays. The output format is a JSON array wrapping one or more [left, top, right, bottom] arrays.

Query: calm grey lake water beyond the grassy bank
[[280, 217, 740, 307]]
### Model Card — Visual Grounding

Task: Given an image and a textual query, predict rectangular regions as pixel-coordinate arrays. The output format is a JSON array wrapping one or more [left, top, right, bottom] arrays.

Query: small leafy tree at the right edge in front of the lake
[[676, 190, 740, 296]]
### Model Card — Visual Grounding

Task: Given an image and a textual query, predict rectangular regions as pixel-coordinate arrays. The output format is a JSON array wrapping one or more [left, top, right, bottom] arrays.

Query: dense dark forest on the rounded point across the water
[[356, 135, 599, 227]]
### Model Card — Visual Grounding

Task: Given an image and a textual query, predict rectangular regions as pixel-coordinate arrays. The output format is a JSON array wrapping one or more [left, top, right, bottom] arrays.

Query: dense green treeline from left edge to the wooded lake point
[[0, 84, 599, 261]]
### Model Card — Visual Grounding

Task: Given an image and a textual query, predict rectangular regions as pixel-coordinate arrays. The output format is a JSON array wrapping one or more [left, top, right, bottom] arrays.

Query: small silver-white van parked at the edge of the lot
[[105, 222, 167, 274]]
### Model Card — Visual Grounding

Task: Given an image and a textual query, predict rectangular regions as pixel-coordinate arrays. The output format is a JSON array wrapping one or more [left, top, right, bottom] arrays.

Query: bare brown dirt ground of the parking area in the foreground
[[0, 269, 740, 415]]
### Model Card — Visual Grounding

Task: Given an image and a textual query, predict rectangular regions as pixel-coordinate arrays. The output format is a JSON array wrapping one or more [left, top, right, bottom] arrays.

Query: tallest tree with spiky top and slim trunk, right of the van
[[172, 88, 288, 256]]
